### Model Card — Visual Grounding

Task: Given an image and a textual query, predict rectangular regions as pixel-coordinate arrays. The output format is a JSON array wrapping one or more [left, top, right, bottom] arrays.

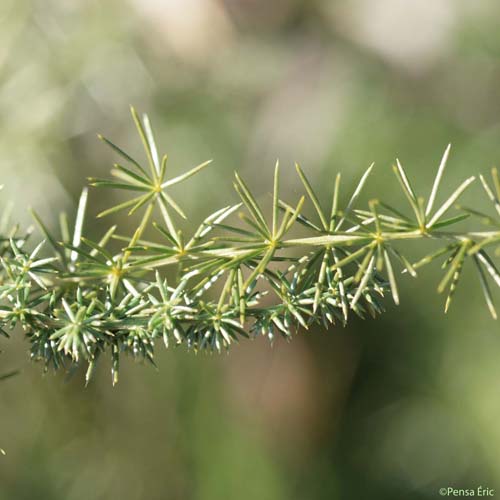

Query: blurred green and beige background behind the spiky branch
[[0, 0, 500, 500]]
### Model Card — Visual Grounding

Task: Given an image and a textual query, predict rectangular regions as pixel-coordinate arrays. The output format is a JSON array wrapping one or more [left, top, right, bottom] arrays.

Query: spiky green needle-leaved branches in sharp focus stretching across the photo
[[0, 110, 500, 383]]
